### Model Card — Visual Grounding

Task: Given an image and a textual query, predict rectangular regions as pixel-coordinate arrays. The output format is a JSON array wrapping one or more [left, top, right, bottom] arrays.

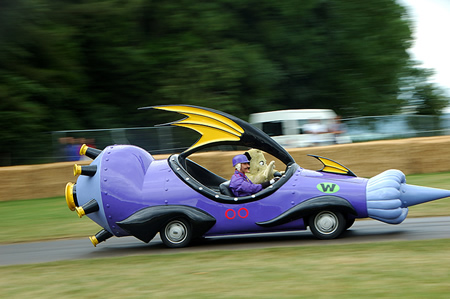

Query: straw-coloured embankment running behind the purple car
[[0, 136, 450, 201]]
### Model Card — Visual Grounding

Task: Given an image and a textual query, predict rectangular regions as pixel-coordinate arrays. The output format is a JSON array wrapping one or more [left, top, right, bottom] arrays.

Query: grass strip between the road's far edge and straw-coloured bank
[[0, 172, 450, 244]]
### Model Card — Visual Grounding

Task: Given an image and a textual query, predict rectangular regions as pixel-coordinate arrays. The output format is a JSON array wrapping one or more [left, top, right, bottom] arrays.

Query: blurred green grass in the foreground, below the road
[[0, 239, 450, 298]]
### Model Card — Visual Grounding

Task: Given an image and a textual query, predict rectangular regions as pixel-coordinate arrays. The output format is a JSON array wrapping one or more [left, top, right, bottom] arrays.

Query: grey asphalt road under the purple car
[[0, 216, 450, 266]]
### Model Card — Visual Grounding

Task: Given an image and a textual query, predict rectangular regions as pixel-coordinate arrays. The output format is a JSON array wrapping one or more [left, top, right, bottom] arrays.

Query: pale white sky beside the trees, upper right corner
[[397, 0, 450, 96]]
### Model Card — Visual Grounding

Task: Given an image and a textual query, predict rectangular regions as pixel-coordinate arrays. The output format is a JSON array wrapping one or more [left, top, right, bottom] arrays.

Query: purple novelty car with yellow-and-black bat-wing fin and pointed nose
[[66, 105, 450, 247]]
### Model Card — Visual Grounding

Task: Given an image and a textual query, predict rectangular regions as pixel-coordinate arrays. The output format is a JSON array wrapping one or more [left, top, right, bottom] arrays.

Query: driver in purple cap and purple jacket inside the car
[[230, 155, 276, 197]]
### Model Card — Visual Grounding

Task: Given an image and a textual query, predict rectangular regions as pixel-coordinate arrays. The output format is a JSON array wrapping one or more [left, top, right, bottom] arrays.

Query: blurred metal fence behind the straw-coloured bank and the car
[[52, 114, 450, 162]]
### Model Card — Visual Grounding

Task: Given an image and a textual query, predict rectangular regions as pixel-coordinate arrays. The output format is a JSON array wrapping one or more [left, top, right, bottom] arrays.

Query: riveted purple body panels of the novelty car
[[77, 145, 367, 237]]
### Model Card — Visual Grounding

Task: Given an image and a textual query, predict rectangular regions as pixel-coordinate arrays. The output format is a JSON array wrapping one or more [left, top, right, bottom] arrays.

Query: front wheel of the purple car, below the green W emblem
[[309, 211, 347, 240]]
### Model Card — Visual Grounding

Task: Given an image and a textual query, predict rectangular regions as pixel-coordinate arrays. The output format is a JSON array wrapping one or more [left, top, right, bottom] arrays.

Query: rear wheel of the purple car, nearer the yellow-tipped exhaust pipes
[[160, 218, 192, 248]]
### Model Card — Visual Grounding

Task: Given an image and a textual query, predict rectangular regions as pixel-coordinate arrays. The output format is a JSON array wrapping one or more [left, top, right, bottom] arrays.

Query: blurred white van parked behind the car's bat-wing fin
[[249, 109, 351, 148]]
